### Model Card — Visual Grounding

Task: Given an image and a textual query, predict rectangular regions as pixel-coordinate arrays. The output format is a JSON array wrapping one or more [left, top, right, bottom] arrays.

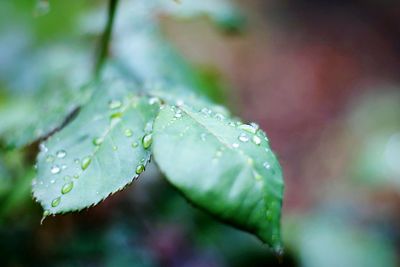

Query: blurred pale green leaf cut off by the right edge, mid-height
[[349, 88, 400, 188]]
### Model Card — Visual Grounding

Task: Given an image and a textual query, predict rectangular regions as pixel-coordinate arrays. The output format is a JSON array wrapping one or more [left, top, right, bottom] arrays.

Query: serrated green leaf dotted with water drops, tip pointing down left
[[33, 83, 159, 215]]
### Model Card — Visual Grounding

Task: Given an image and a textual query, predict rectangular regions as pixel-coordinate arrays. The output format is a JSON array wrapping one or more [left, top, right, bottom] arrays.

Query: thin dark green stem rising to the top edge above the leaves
[[94, 0, 119, 77]]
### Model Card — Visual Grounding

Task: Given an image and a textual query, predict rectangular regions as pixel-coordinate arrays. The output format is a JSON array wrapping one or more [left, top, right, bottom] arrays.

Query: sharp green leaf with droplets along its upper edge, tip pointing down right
[[152, 105, 283, 252]]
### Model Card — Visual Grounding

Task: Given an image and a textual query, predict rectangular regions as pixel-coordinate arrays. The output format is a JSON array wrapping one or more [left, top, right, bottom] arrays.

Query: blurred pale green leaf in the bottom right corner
[[297, 217, 397, 267]]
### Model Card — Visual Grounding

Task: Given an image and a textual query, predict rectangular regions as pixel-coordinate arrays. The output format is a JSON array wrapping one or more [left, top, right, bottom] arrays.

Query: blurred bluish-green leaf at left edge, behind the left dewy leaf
[[0, 46, 92, 147]]
